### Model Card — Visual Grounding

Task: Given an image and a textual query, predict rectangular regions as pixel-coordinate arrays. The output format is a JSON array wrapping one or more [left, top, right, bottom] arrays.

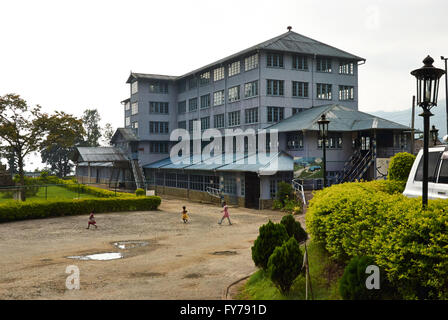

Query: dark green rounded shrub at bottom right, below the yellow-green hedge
[[339, 256, 397, 300]]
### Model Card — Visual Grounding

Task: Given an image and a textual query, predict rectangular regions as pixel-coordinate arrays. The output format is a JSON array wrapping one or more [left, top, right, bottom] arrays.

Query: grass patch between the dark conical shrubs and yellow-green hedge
[[237, 242, 344, 300]]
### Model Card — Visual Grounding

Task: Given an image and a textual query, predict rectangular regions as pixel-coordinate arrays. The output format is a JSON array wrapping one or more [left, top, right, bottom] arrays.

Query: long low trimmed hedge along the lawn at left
[[0, 195, 161, 222]]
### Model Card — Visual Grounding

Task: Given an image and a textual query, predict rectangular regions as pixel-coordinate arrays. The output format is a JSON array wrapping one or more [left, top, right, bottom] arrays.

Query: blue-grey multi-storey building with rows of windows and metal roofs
[[75, 30, 410, 207]]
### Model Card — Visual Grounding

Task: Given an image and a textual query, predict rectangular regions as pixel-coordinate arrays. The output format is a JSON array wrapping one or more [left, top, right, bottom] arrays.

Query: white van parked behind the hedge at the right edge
[[403, 145, 448, 199]]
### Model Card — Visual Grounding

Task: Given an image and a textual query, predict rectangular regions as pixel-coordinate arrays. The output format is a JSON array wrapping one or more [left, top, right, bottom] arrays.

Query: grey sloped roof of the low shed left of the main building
[[74, 147, 129, 162]]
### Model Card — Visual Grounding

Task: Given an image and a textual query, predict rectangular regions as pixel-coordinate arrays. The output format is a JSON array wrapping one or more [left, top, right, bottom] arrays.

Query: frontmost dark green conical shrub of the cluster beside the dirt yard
[[268, 237, 303, 293]]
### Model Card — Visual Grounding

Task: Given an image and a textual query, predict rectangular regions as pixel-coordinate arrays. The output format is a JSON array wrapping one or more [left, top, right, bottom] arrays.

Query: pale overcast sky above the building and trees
[[0, 0, 448, 170]]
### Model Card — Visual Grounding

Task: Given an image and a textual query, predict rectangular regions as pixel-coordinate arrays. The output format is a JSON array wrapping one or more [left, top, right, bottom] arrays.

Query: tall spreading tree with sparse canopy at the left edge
[[0, 94, 48, 200]]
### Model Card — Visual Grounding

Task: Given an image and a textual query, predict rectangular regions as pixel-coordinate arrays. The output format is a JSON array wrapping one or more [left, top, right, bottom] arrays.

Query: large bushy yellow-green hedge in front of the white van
[[306, 181, 448, 299]]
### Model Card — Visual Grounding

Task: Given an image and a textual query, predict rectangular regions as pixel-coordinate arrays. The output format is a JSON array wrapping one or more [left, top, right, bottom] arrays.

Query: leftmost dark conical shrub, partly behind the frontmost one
[[252, 220, 289, 270]]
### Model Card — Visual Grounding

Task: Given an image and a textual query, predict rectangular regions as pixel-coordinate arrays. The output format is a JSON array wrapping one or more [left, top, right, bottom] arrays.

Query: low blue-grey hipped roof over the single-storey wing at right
[[267, 104, 410, 132]]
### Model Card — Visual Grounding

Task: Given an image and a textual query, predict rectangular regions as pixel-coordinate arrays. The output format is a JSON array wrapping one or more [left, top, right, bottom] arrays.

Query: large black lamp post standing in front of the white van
[[411, 56, 445, 209]]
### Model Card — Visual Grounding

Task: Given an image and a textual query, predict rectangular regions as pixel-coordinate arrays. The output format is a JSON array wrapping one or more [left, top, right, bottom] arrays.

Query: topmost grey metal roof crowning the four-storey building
[[126, 31, 366, 83]]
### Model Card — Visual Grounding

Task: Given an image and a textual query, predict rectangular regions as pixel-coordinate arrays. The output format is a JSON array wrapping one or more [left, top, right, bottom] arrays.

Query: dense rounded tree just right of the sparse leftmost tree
[[41, 112, 85, 178]]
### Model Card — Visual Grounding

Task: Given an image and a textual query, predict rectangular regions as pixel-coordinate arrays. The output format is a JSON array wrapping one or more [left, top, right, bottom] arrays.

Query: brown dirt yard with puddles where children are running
[[0, 198, 304, 299]]
